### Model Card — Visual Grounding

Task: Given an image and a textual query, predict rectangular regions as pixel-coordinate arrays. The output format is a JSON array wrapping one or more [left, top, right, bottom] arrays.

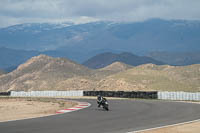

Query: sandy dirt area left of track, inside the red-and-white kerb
[[0, 98, 77, 122]]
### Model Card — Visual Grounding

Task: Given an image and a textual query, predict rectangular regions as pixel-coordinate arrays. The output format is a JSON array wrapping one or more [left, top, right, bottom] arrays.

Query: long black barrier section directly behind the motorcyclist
[[83, 91, 158, 99]]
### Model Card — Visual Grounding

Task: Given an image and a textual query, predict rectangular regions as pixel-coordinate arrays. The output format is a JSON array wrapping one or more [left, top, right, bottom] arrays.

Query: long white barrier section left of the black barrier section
[[10, 91, 83, 97]]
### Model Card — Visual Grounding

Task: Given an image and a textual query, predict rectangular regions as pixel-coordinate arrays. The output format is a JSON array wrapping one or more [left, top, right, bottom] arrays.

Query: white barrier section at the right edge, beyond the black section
[[158, 91, 200, 101]]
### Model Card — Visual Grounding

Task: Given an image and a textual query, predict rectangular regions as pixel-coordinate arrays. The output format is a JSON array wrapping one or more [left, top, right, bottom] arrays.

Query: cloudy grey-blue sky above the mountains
[[0, 0, 200, 27]]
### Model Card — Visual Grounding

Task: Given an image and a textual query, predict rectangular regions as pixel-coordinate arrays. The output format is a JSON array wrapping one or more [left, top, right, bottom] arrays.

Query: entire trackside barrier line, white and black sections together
[[7, 91, 200, 101]]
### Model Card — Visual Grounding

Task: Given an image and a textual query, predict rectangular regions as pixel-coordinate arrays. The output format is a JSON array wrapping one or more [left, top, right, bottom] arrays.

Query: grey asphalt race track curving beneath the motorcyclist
[[0, 100, 200, 133]]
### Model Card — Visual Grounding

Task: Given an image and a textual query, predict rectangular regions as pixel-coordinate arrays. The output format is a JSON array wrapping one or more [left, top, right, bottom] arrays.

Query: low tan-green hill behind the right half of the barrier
[[98, 64, 200, 92]]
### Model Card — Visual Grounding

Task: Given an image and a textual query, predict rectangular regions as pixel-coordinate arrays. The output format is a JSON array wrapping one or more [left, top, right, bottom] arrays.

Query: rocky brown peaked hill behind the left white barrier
[[0, 55, 97, 91]]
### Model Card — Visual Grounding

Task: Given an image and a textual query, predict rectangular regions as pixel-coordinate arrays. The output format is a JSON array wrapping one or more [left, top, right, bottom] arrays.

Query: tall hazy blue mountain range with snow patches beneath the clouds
[[0, 19, 200, 59]]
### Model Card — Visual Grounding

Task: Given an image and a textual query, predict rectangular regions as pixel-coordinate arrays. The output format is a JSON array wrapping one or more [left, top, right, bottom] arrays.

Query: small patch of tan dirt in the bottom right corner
[[140, 121, 200, 133]]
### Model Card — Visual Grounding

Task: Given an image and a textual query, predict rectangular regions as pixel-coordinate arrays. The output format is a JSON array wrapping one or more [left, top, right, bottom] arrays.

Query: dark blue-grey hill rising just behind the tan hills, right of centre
[[83, 52, 164, 69]]
